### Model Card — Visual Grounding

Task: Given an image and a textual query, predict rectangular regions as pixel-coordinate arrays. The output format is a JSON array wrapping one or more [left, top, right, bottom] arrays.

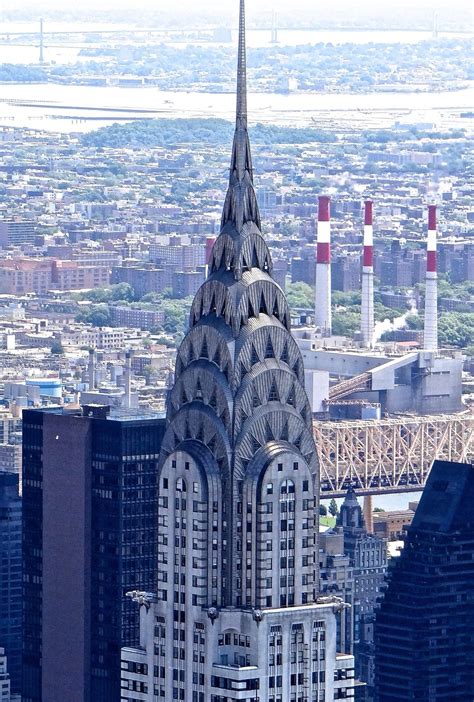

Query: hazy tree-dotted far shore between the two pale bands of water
[[0, 37, 473, 93]]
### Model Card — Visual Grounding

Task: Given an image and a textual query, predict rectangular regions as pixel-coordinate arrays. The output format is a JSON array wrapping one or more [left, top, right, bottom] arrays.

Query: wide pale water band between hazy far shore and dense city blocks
[[0, 81, 474, 132]]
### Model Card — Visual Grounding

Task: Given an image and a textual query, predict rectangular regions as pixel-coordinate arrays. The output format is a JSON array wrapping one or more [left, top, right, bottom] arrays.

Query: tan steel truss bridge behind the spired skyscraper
[[314, 412, 474, 498]]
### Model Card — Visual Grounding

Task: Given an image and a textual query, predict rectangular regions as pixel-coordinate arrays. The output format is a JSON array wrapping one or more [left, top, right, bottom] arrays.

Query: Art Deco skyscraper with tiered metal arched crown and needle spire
[[122, 0, 353, 702]]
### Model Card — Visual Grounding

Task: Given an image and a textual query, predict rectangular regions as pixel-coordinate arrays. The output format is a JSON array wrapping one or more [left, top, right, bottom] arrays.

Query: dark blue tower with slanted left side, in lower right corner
[[375, 461, 474, 702]]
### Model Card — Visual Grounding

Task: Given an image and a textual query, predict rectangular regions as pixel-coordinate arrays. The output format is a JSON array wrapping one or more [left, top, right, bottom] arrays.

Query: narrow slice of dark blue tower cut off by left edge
[[0, 472, 22, 697]]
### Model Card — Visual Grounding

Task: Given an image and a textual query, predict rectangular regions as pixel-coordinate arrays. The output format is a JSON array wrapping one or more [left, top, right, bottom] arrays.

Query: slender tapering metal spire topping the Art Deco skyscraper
[[222, 0, 260, 232]]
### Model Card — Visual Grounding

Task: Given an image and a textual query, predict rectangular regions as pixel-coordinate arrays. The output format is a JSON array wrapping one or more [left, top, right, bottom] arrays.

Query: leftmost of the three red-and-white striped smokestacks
[[314, 195, 332, 336]]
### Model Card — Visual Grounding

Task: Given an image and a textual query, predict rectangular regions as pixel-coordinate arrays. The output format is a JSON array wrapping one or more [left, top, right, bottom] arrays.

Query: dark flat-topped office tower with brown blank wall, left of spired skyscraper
[[23, 406, 164, 702]]
